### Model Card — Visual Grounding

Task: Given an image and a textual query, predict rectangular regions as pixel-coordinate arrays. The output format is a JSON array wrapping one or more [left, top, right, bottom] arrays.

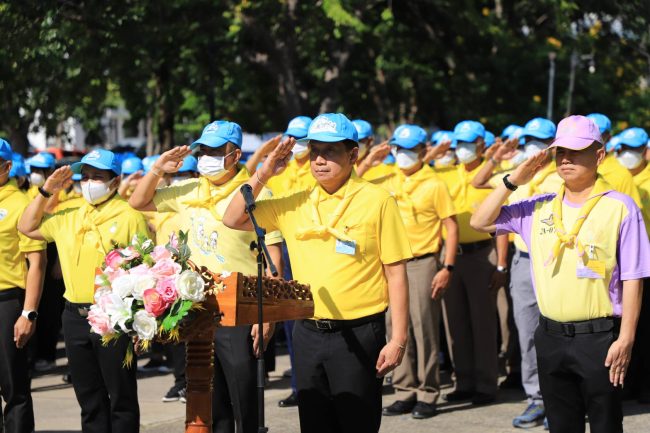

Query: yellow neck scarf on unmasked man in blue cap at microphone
[[296, 171, 362, 242]]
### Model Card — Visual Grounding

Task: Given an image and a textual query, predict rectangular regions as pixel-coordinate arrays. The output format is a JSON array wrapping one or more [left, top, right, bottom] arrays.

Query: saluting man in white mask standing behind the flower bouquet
[[18, 149, 147, 433]]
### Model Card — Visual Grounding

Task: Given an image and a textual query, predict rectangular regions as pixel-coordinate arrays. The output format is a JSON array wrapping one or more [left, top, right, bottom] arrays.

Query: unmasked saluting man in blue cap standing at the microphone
[[224, 113, 411, 433]]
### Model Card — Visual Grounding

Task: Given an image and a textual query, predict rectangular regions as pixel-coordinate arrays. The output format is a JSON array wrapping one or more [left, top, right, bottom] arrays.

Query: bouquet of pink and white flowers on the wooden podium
[[88, 231, 206, 366]]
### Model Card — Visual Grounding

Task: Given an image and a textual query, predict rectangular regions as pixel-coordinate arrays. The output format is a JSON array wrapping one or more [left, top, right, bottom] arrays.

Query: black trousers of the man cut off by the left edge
[[0, 289, 34, 433]]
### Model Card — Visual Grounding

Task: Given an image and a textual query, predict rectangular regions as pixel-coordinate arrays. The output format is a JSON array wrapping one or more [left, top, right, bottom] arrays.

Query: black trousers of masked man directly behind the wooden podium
[[212, 326, 258, 433]]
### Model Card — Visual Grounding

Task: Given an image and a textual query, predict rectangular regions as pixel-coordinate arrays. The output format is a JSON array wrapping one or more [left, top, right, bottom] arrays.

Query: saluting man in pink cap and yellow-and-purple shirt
[[471, 116, 650, 433]]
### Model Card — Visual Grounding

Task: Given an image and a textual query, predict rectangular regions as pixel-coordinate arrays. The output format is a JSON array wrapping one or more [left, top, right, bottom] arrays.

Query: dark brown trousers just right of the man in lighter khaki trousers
[[444, 246, 498, 394]]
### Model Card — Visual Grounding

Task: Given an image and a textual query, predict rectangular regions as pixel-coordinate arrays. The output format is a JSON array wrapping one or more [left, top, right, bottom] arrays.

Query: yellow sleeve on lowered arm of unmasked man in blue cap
[[377, 197, 413, 265]]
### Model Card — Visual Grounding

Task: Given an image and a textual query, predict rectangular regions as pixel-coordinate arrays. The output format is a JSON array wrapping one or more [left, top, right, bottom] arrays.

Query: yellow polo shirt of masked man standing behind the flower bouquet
[[39, 194, 149, 303]]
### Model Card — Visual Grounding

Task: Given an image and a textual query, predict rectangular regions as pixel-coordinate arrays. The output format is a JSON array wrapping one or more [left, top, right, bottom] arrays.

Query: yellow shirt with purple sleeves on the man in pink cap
[[496, 177, 650, 322]]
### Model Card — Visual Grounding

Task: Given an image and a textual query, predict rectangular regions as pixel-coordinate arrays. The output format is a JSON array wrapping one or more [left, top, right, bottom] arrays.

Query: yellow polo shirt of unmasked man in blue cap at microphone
[[256, 171, 412, 320]]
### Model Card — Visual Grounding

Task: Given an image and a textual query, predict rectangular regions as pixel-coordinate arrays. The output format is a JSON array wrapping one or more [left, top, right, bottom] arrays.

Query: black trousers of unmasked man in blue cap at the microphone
[[293, 315, 386, 433]]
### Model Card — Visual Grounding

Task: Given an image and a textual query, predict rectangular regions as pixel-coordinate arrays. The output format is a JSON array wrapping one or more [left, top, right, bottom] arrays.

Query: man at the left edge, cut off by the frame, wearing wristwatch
[[0, 139, 45, 433]]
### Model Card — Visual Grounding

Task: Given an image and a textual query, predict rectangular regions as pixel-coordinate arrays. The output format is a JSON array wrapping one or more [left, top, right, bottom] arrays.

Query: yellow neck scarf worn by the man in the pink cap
[[544, 176, 612, 266]]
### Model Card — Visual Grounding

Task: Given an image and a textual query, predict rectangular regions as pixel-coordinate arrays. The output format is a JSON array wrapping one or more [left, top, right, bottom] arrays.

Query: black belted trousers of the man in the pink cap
[[535, 318, 623, 433]]
